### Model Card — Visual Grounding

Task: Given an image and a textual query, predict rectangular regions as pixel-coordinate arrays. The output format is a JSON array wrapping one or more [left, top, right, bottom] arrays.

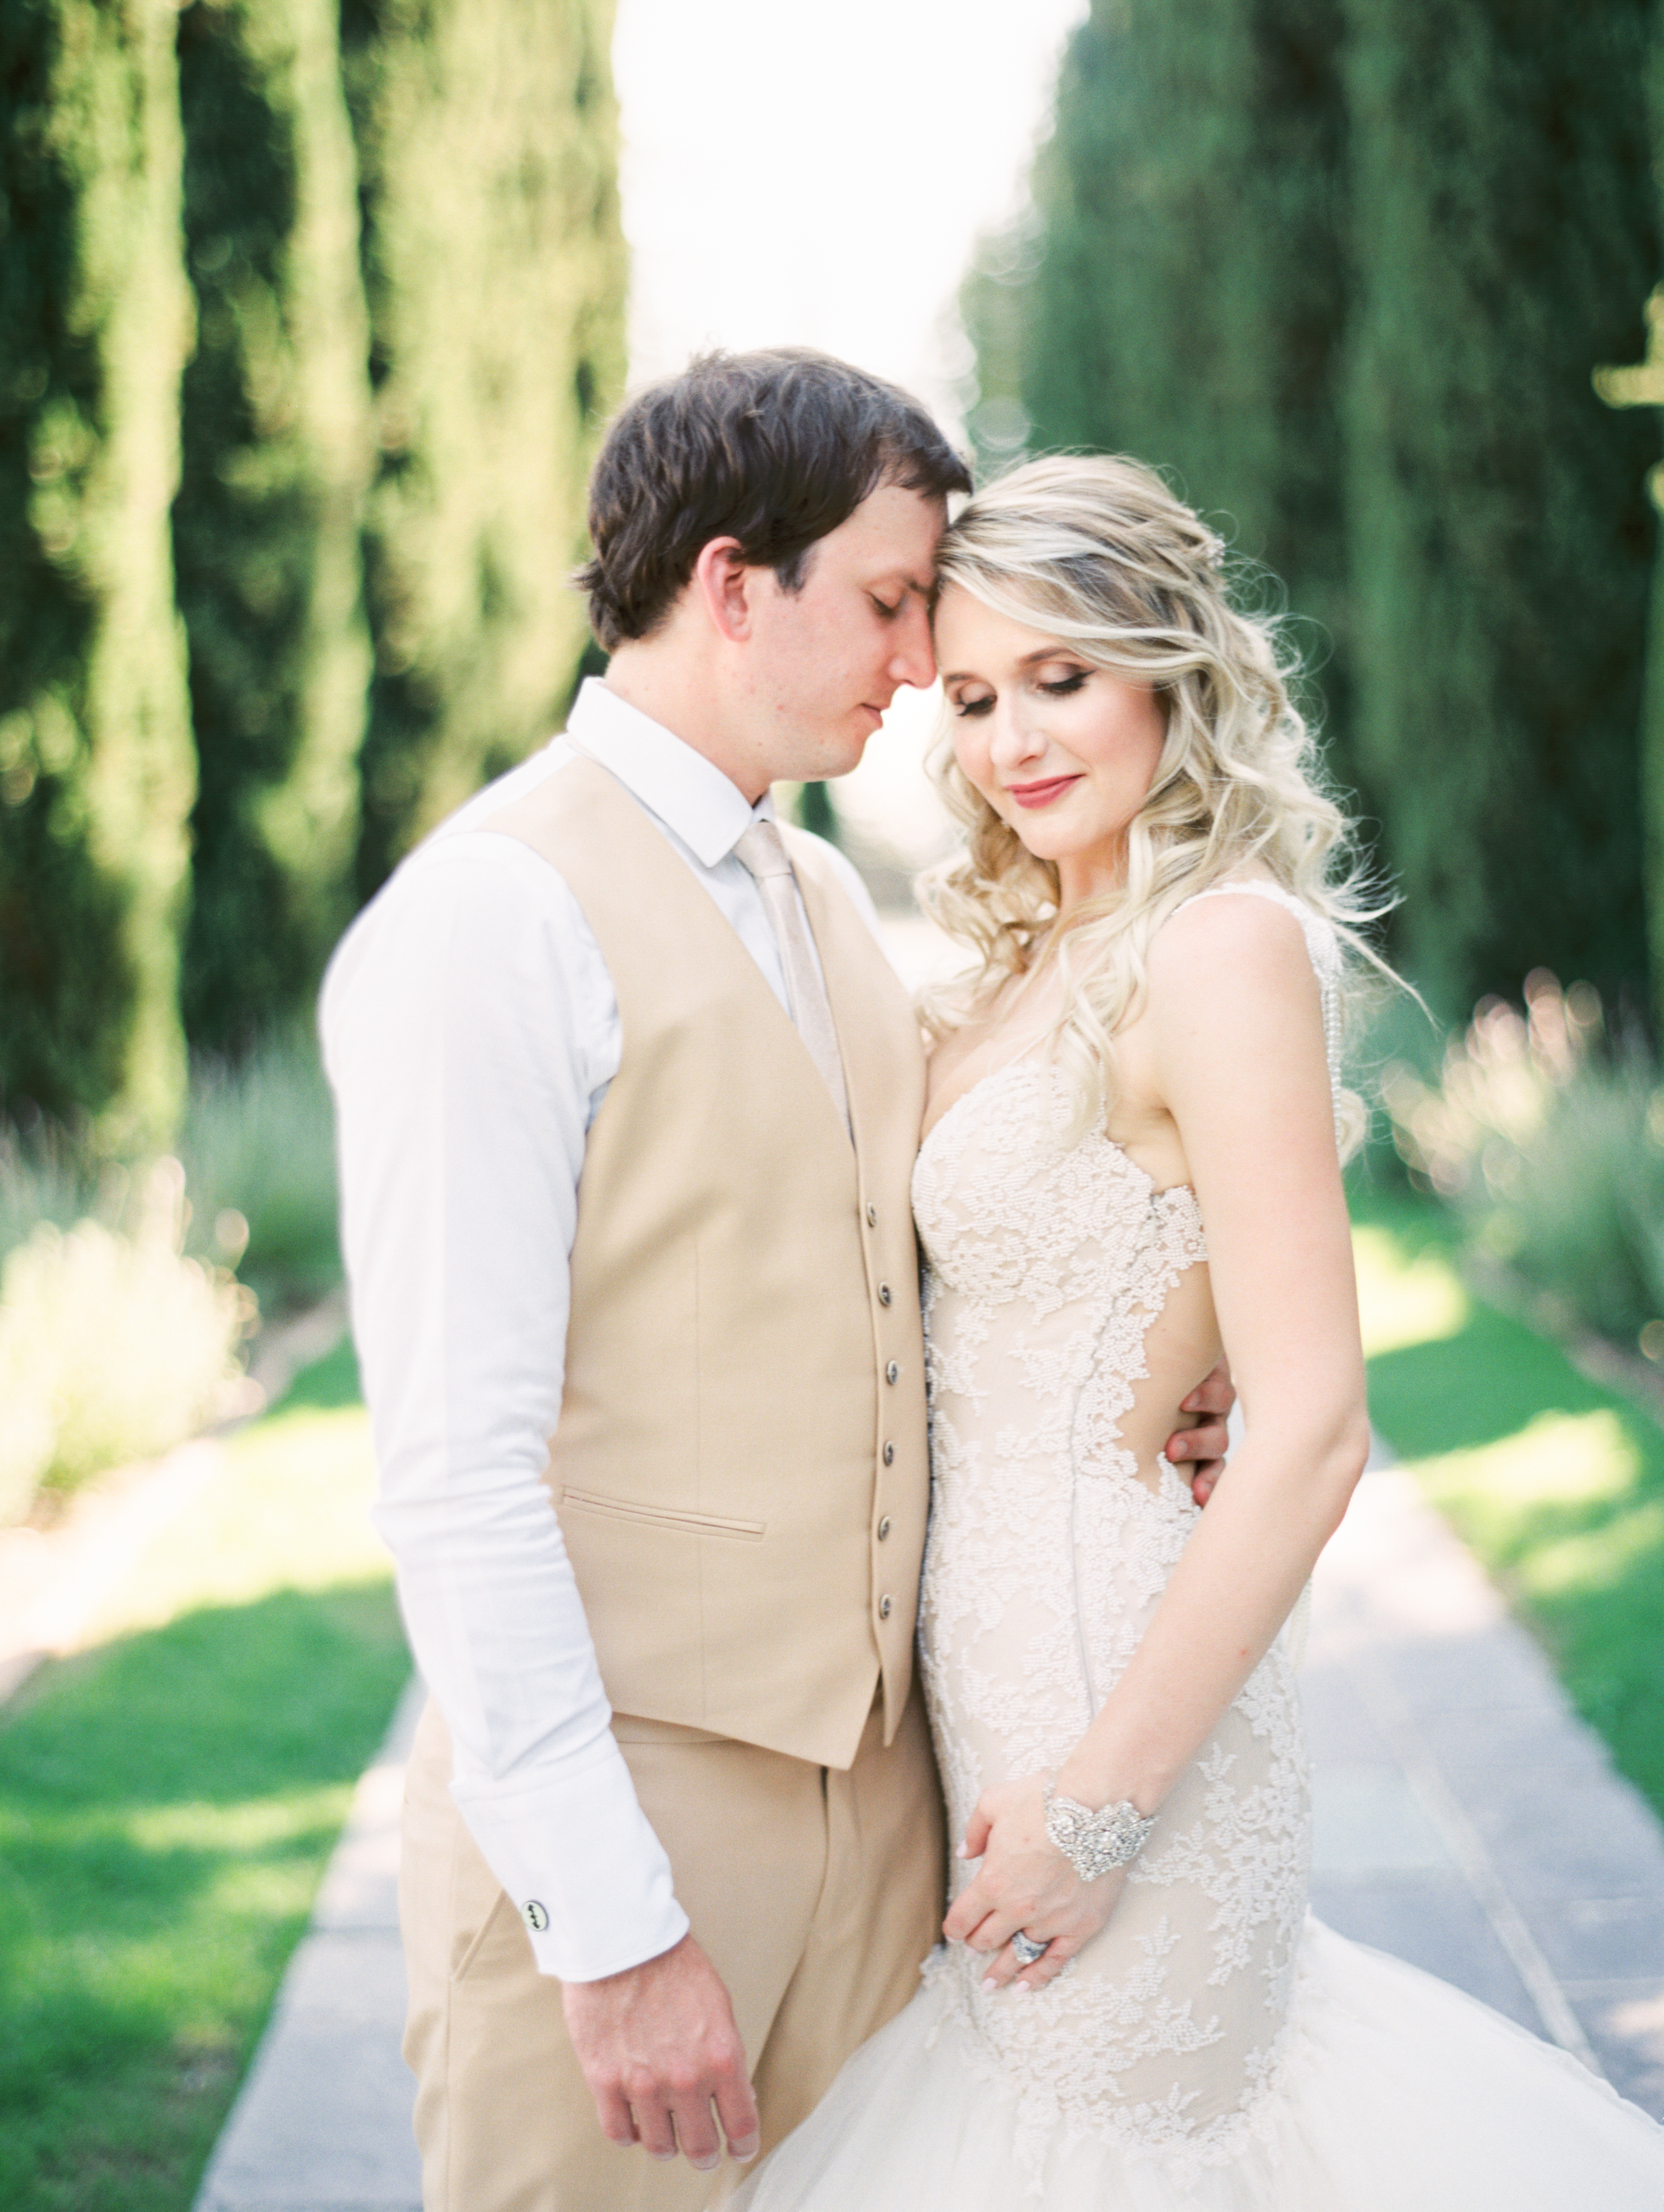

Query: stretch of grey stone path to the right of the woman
[[1301, 1467, 1664, 2119]]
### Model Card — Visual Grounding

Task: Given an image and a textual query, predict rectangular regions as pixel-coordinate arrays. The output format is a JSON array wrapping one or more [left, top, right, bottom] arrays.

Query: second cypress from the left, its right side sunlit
[[175, 0, 372, 1048]]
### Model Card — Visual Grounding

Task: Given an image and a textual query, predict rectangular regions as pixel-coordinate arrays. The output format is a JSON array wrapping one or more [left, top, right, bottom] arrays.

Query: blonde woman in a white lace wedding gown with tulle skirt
[[739, 458, 1664, 2212]]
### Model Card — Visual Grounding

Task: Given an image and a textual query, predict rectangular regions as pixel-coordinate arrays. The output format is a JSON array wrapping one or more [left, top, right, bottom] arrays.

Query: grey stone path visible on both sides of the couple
[[197, 1464, 1664, 2212]]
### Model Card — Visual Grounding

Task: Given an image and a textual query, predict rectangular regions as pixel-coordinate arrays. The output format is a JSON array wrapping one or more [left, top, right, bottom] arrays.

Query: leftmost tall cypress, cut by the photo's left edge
[[0, 0, 195, 1146]]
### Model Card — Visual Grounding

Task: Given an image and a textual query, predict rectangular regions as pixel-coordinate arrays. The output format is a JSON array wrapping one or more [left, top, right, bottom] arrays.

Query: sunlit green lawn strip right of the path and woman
[[1352, 1194, 1664, 1814]]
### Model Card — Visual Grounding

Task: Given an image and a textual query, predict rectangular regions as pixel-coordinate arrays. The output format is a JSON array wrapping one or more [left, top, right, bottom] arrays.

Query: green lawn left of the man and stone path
[[0, 1347, 409, 2212]]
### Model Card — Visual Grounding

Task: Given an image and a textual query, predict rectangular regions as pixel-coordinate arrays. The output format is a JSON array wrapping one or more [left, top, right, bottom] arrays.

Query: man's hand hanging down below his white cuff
[[562, 1935, 759, 2172]]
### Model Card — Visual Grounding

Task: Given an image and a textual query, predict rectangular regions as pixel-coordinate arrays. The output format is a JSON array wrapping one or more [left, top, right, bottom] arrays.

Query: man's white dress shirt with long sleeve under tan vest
[[321, 679, 878, 1982]]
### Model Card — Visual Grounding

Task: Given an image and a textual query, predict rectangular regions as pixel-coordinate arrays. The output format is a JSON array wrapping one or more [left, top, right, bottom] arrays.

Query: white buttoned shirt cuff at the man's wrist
[[451, 1734, 688, 1982]]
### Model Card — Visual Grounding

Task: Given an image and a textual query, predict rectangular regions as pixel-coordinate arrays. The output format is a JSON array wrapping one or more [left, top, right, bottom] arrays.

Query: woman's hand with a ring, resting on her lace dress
[[943, 1774, 1127, 1988]]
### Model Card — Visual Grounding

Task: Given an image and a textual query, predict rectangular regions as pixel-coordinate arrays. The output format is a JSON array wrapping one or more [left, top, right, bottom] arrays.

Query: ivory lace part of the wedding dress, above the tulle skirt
[[914, 885, 1341, 2165]]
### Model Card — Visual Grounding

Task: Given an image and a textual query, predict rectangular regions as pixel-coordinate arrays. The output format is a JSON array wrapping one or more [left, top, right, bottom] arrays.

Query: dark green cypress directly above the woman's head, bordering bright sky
[[967, 0, 1356, 783]]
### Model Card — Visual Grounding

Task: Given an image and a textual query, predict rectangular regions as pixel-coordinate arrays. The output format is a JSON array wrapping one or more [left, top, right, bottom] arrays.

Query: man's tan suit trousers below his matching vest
[[398, 1690, 945, 2212]]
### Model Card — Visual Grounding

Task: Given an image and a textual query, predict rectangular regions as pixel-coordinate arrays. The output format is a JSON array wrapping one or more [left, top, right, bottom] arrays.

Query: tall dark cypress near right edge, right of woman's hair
[[1346, 0, 1659, 1015]]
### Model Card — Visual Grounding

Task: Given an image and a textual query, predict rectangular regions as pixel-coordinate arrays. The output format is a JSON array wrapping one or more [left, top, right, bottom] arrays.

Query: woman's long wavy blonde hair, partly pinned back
[[920, 455, 1390, 1150]]
